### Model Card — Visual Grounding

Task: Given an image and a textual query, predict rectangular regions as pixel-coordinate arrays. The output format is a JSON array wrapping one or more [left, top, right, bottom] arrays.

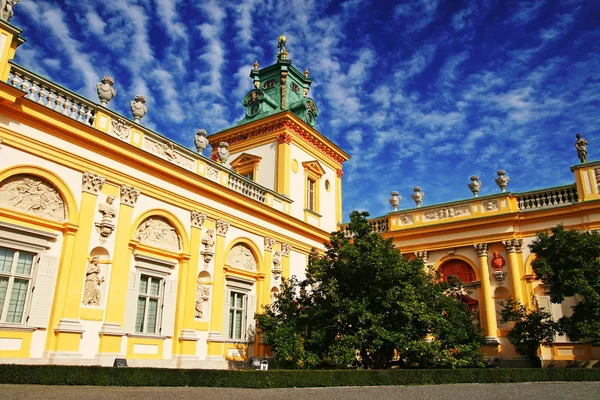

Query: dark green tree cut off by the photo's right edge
[[529, 225, 600, 346]]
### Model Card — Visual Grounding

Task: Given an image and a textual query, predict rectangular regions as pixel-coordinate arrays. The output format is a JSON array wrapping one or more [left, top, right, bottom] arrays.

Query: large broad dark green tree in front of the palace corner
[[258, 211, 483, 368]]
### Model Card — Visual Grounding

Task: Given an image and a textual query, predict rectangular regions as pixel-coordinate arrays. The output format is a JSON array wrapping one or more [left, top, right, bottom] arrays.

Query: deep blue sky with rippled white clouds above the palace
[[11, 0, 600, 220]]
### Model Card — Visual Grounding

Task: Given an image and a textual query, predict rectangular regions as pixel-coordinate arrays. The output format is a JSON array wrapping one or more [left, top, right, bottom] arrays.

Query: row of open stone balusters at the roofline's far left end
[[8, 62, 98, 125]]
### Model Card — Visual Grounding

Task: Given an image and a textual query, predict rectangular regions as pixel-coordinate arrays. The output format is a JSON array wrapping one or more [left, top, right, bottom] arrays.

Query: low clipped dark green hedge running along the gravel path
[[0, 364, 600, 388]]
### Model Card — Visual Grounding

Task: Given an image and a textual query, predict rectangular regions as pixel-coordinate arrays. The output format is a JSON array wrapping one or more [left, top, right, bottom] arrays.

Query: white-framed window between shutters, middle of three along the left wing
[[135, 275, 164, 333]]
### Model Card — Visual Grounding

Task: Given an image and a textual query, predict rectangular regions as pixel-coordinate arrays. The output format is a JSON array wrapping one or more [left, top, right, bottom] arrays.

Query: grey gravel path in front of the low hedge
[[0, 382, 600, 400]]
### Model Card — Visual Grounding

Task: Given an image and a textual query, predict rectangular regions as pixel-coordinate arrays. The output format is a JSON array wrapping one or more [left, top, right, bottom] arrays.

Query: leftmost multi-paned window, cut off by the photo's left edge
[[0, 247, 37, 324]]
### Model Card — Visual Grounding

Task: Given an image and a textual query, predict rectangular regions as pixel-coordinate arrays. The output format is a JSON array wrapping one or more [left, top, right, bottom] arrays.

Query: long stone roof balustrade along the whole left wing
[[8, 62, 291, 212]]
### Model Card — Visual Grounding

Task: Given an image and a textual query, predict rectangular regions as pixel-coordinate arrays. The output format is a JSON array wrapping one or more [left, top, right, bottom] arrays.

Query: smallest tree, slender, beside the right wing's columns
[[500, 298, 558, 366]]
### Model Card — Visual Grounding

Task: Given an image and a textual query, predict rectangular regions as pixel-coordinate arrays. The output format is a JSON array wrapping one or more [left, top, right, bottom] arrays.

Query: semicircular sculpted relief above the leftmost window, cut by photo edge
[[0, 174, 67, 221]]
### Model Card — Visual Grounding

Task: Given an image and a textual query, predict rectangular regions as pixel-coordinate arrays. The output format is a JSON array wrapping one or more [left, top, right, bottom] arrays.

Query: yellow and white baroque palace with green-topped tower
[[0, 21, 600, 368]]
